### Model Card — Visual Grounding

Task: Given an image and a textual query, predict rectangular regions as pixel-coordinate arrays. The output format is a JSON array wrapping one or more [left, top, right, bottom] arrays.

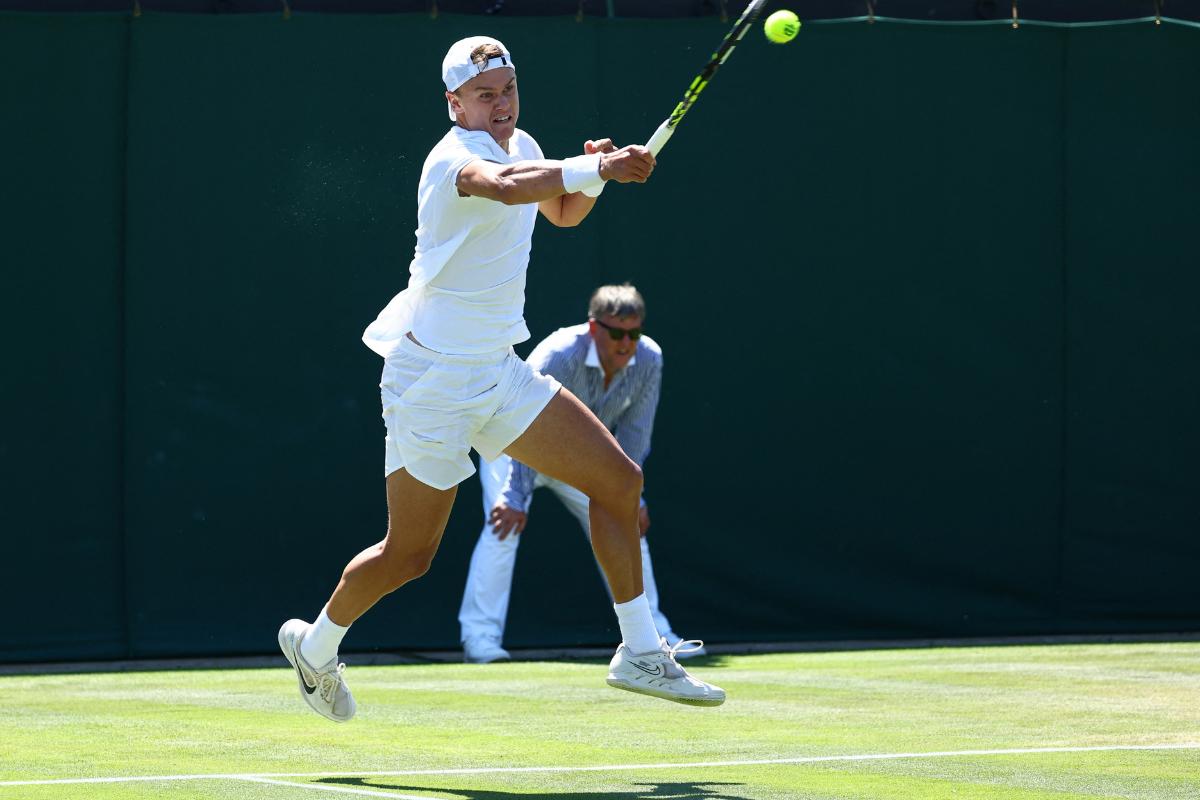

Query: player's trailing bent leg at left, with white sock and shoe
[[278, 469, 457, 722]]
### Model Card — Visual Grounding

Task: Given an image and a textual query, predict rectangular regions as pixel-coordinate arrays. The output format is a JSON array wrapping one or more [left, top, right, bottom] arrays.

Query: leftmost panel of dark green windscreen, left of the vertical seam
[[0, 14, 128, 660]]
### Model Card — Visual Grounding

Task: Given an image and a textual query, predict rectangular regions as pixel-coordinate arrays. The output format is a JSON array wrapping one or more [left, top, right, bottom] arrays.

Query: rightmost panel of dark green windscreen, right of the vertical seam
[[1062, 26, 1200, 630]]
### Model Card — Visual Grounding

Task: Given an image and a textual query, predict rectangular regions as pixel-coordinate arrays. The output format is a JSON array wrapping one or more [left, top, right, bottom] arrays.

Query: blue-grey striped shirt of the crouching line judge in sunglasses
[[500, 323, 662, 511]]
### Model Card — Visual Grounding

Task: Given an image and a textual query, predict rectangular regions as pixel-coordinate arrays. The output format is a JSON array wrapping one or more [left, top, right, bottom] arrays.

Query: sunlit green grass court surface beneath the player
[[0, 643, 1200, 800]]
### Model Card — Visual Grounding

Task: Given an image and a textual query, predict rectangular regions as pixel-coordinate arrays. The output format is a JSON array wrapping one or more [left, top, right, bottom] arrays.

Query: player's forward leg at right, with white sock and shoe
[[505, 389, 725, 705]]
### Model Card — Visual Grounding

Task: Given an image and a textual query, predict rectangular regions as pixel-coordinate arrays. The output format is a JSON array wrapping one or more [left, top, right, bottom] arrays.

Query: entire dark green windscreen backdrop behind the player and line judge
[[0, 14, 1200, 661]]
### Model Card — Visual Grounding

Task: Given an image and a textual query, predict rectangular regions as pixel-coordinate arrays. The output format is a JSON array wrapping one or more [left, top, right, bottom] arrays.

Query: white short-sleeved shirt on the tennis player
[[362, 125, 542, 357]]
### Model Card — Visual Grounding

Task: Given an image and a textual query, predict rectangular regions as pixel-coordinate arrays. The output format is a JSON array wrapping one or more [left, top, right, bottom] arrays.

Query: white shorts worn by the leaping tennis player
[[379, 337, 563, 489]]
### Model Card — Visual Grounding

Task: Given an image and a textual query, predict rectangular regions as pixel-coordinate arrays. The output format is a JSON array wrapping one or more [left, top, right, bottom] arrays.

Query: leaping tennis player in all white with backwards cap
[[278, 36, 725, 722]]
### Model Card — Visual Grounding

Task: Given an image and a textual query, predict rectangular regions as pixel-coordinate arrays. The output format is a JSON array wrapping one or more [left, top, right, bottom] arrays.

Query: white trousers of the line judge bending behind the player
[[458, 455, 671, 642]]
